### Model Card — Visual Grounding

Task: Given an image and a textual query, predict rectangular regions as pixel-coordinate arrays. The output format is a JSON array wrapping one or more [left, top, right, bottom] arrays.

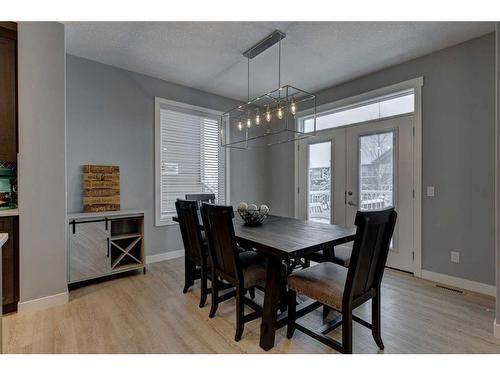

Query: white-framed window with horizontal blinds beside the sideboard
[[155, 98, 227, 225]]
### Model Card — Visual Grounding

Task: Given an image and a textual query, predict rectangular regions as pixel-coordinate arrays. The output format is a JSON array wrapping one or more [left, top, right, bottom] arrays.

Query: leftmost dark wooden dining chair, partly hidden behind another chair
[[175, 199, 209, 307]]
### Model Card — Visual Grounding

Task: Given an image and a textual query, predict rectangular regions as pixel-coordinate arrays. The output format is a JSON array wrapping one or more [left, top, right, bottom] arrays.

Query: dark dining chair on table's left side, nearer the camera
[[201, 203, 266, 341]]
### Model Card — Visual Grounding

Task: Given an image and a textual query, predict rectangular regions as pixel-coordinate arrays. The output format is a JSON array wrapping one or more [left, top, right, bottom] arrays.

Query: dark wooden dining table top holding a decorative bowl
[[174, 213, 356, 260]]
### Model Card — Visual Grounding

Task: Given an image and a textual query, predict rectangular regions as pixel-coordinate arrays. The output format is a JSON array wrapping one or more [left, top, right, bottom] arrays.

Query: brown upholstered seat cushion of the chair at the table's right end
[[288, 262, 348, 311]]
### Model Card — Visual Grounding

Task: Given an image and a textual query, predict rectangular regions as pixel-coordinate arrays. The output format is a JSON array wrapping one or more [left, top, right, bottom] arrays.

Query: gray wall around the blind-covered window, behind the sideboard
[[66, 55, 267, 255]]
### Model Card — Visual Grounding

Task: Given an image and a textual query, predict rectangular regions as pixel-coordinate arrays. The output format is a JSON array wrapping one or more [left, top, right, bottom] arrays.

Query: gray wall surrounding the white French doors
[[269, 34, 495, 285]]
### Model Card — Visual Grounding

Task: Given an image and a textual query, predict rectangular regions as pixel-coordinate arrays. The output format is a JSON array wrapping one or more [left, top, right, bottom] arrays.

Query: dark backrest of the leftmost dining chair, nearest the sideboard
[[175, 199, 204, 261]]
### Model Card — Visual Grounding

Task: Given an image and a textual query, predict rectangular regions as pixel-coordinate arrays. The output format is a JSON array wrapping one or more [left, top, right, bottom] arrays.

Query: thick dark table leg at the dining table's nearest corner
[[260, 257, 282, 350]]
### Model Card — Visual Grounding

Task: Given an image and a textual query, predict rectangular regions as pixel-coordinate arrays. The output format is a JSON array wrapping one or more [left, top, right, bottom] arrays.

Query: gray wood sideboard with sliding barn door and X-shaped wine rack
[[68, 210, 146, 284]]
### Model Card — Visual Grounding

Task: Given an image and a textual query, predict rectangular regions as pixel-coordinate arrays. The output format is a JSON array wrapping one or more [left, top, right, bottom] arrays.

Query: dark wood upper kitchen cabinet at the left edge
[[0, 22, 17, 162]]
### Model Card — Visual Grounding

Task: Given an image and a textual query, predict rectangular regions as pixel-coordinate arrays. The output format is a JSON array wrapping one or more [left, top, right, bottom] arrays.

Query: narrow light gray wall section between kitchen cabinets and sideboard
[[18, 22, 67, 302]]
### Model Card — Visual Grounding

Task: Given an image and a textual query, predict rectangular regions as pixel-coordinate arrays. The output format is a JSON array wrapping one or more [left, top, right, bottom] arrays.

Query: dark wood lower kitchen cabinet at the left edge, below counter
[[0, 216, 19, 314]]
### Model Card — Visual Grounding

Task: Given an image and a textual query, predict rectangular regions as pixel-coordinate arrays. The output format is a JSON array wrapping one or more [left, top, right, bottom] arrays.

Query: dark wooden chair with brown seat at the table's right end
[[287, 208, 397, 353]]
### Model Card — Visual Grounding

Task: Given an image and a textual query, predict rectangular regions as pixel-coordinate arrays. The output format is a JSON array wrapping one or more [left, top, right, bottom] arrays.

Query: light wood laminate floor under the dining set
[[0, 258, 500, 353]]
